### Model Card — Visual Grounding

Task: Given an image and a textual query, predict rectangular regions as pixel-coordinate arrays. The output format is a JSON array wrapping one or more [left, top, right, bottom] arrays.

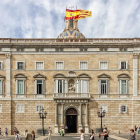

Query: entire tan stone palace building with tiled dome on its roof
[[0, 19, 140, 134]]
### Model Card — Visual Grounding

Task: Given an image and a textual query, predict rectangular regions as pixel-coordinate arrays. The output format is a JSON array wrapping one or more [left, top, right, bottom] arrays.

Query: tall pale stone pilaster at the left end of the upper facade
[[5, 53, 11, 97]]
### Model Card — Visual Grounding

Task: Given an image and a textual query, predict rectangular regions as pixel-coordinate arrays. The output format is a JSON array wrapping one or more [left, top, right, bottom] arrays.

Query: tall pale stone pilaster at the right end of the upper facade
[[133, 53, 139, 96]]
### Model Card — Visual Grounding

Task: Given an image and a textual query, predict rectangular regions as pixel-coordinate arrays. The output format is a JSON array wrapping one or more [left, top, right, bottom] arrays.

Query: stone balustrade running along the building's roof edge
[[0, 38, 140, 44]]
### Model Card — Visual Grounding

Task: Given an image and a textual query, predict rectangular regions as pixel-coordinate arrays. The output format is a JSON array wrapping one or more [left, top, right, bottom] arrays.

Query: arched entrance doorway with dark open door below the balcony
[[66, 108, 78, 133]]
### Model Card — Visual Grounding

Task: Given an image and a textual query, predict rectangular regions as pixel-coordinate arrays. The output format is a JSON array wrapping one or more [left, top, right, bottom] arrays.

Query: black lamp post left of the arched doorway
[[39, 108, 47, 136]]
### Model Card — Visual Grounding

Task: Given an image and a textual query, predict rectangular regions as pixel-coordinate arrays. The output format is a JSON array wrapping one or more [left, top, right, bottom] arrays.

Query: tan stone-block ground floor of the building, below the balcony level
[[0, 99, 140, 134]]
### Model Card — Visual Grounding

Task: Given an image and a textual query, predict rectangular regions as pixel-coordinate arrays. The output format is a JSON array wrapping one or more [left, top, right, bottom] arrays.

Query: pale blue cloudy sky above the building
[[0, 0, 140, 38]]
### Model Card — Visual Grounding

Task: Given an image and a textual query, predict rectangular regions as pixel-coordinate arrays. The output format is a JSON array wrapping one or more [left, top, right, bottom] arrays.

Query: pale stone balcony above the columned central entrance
[[53, 93, 91, 99]]
